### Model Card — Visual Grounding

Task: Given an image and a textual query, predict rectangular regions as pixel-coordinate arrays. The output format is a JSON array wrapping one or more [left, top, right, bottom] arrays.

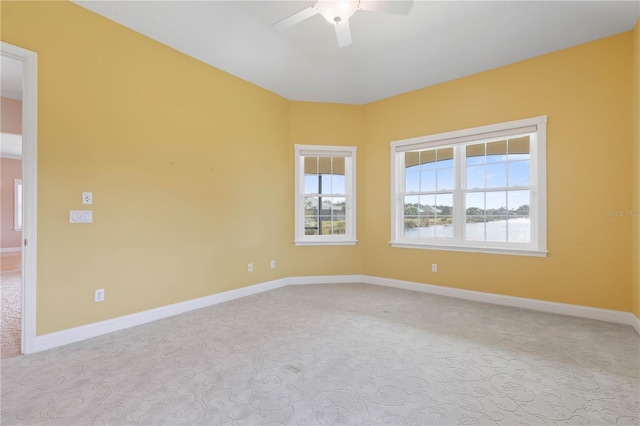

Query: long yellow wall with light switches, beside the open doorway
[[2, 1, 292, 335]]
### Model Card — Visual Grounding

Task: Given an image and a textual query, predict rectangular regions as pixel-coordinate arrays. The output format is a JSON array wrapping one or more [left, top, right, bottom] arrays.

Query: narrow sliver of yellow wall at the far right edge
[[631, 19, 640, 319]]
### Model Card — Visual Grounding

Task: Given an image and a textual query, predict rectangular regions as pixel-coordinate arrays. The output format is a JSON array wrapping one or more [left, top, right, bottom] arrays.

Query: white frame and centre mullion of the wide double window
[[390, 115, 548, 257]]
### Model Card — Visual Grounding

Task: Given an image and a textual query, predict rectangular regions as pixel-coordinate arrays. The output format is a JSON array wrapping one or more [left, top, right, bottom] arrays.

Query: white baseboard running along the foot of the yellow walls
[[32, 275, 640, 352]]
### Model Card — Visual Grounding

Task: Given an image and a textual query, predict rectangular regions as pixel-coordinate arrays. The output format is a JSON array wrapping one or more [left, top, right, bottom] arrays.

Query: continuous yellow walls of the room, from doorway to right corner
[[0, 1, 638, 335]]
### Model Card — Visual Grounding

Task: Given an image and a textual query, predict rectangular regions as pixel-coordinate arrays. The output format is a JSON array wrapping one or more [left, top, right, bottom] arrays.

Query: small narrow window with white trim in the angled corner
[[295, 145, 356, 245]]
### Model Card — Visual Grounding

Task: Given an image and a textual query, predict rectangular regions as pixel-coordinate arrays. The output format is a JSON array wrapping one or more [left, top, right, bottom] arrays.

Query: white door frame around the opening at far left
[[0, 42, 38, 354]]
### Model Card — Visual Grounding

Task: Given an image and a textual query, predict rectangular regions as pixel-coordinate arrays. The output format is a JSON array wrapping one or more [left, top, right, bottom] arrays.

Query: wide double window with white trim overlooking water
[[391, 116, 547, 256]]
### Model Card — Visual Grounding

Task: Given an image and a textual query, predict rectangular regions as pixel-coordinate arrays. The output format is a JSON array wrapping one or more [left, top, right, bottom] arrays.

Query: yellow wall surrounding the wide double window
[[359, 32, 632, 311]]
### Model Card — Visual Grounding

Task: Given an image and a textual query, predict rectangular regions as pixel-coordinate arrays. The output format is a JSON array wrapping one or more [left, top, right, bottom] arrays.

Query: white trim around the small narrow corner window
[[294, 145, 357, 246]]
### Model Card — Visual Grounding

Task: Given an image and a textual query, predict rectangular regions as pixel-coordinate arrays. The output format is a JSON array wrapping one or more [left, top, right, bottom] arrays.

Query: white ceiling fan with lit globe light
[[273, 0, 413, 47]]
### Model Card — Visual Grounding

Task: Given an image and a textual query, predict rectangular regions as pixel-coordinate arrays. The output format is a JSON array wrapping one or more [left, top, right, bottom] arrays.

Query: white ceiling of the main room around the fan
[[41, 0, 640, 104]]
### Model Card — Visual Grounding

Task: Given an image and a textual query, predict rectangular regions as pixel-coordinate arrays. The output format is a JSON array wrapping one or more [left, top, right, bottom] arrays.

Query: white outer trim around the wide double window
[[390, 115, 548, 257]]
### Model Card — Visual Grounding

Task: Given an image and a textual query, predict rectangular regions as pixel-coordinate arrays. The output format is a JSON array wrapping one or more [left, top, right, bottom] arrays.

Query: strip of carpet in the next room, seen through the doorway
[[0, 271, 22, 358]]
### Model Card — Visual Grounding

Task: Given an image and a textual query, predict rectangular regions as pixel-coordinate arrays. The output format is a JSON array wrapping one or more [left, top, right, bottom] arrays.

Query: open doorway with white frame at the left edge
[[0, 42, 37, 358]]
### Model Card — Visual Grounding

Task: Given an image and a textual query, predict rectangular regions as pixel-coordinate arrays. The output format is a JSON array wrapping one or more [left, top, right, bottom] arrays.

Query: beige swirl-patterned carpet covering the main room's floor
[[0, 284, 640, 425]]
